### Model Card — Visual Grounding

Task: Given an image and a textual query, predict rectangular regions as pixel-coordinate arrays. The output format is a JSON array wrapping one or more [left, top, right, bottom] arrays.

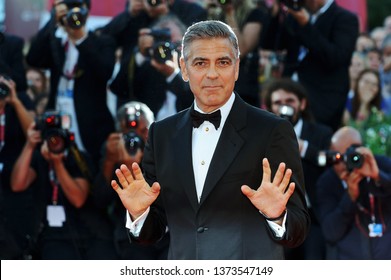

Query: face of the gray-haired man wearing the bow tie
[[180, 38, 239, 113]]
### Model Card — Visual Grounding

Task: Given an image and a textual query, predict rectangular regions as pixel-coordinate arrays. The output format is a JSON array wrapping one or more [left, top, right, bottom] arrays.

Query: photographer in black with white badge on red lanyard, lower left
[[11, 111, 115, 260]]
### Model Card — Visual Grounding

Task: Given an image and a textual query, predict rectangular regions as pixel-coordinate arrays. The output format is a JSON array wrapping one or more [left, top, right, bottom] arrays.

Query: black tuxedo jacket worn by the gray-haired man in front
[[139, 95, 310, 259]]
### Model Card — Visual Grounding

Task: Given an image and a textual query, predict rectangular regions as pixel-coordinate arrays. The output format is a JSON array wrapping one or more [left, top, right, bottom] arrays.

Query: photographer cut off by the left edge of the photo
[[0, 75, 39, 260]]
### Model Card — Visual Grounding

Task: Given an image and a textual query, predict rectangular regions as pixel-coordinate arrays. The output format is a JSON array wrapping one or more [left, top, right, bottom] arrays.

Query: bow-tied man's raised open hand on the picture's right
[[242, 158, 295, 221]]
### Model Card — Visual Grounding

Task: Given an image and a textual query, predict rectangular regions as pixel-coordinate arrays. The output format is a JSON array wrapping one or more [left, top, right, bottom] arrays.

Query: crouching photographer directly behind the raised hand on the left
[[93, 101, 169, 260]]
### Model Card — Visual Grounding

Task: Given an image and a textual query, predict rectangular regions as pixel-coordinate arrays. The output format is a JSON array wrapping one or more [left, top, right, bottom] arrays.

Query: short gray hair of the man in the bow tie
[[182, 20, 240, 61]]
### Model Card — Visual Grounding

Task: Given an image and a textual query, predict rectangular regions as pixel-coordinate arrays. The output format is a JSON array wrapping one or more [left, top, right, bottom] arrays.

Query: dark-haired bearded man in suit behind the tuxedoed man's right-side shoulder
[[264, 78, 333, 260]]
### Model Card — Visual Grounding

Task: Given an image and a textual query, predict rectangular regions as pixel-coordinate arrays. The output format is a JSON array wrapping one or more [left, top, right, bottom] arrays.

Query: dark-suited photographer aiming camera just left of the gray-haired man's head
[[110, 0, 193, 120]]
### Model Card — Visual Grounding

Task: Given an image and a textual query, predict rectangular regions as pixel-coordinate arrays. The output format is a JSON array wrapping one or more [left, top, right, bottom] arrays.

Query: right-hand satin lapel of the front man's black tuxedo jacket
[[200, 95, 246, 204]]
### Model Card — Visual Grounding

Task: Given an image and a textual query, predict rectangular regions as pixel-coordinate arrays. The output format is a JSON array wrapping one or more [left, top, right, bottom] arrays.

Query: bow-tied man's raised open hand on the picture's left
[[111, 163, 160, 220]]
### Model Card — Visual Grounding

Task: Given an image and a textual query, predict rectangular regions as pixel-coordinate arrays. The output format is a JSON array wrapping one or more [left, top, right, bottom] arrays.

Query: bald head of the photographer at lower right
[[330, 126, 362, 153]]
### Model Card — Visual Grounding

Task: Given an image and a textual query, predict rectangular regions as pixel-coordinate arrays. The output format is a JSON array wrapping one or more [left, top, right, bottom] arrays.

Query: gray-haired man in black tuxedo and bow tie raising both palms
[[111, 21, 310, 259]]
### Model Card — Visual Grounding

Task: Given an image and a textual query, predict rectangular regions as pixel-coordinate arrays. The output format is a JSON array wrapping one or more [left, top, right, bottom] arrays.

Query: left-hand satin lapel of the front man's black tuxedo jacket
[[172, 105, 198, 211]]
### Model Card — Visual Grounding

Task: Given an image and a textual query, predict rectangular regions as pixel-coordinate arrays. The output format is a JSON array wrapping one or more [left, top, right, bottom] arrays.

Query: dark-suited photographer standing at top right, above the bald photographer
[[262, 0, 359, 131]]
